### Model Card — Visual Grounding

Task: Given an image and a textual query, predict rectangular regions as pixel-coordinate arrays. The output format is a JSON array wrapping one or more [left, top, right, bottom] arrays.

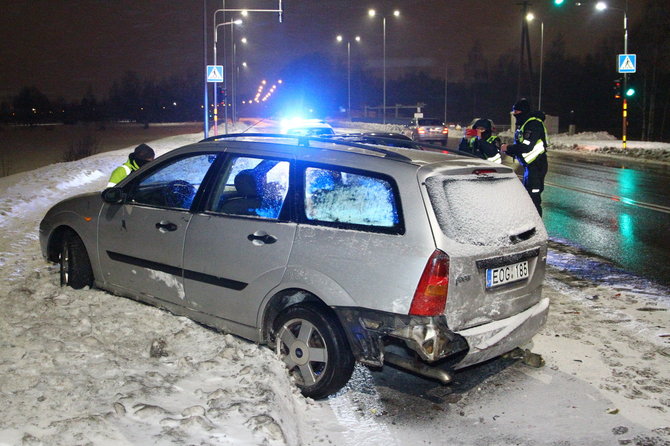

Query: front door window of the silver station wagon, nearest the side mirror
[[130, 154, 216, 209]]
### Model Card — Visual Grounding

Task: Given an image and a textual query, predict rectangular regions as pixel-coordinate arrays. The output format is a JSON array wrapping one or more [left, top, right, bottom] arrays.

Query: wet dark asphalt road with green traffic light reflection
[[542, 152, 670, 286]]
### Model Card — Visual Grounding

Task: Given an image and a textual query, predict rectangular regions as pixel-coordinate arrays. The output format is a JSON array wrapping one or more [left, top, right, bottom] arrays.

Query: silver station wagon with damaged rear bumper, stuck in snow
[[40, 134, 549, 398]]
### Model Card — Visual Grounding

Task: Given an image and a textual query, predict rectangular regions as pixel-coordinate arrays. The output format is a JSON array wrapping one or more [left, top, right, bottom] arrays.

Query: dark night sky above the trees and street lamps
[[0, 0, 644, 99]]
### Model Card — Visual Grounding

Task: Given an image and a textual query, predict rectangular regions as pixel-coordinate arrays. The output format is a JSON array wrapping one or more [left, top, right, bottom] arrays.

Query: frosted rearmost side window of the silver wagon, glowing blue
[[304, 167, 401, 232]]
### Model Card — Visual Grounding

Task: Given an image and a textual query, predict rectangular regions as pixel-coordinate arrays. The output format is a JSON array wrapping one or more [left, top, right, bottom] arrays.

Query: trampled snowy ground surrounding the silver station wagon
[[0, 126, 670, 446]]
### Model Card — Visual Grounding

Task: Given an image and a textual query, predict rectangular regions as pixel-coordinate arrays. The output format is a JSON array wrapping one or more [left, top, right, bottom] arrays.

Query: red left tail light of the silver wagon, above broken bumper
[[409, 249, 449, 316]]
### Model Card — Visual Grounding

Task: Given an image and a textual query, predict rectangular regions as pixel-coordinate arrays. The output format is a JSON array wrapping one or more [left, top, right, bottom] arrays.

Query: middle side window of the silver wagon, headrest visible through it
[[207, 156, 290, 219]]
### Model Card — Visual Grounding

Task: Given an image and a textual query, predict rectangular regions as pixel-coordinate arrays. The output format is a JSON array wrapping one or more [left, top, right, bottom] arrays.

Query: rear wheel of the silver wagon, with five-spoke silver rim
[[275, 304, 355, 399]]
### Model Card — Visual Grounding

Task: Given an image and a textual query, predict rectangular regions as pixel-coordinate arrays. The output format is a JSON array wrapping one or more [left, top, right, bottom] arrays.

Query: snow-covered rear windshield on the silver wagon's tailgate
[[426, 175, 539, 246]]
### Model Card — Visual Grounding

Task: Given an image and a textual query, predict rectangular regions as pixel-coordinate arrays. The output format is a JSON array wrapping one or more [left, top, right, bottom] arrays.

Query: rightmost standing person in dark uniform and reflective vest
[[500, 98, 549, 216]]
